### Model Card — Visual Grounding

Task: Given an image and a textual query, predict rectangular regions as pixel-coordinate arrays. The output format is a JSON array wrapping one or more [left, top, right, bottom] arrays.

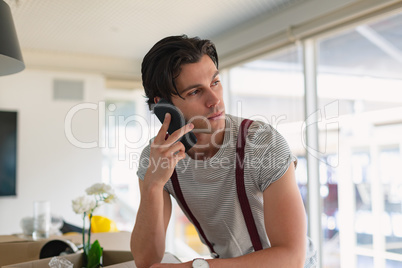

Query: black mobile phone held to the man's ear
[[154, 98, 197, 152]]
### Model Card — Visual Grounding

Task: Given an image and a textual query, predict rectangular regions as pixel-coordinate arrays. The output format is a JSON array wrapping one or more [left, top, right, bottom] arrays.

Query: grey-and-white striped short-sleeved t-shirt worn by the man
[[137, 115, 316, 266]]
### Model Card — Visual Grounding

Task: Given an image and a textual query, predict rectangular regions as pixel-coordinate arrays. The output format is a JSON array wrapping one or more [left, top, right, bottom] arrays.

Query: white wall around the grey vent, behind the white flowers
[[0, 70, 105, 235]]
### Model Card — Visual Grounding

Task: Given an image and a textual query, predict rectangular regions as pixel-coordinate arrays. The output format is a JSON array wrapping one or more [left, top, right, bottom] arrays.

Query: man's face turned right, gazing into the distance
[[172, 55, 225, 133]]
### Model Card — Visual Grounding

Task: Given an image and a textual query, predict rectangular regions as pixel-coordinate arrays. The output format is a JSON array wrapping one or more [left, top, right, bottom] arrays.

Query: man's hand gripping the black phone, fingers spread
[[144, 113, 194, 187]]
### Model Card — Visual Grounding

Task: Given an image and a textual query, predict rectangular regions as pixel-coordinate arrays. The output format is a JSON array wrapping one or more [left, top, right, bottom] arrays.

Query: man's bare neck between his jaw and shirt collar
[[187, 130, 225, 160]]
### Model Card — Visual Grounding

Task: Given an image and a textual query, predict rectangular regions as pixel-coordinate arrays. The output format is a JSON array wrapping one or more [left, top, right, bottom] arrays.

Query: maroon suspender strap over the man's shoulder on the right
[[236, 119, 262, 251]]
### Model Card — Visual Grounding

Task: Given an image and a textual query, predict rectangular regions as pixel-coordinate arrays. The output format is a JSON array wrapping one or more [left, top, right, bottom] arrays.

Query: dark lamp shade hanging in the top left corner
[[0, 0, 25, 75]]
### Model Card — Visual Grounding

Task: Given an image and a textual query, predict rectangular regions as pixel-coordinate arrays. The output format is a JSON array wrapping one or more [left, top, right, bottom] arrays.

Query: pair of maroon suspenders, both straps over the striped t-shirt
[[170, 119, 262, 258]]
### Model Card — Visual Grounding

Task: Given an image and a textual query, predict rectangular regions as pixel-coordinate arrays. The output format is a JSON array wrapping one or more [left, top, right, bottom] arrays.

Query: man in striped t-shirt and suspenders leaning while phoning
[[131, 36, 315, 268]]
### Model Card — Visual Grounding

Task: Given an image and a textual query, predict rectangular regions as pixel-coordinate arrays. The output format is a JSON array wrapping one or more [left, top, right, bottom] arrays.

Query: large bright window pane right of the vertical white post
[[317, 11, 402, 268]]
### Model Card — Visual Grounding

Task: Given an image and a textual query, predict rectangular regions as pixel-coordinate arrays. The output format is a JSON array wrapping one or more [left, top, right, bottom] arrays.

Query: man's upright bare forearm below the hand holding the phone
[[131, 185, 166, 267]]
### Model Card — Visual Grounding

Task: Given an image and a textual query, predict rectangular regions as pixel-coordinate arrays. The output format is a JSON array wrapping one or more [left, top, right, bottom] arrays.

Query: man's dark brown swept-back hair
[[141, 35, 218, 110]]
